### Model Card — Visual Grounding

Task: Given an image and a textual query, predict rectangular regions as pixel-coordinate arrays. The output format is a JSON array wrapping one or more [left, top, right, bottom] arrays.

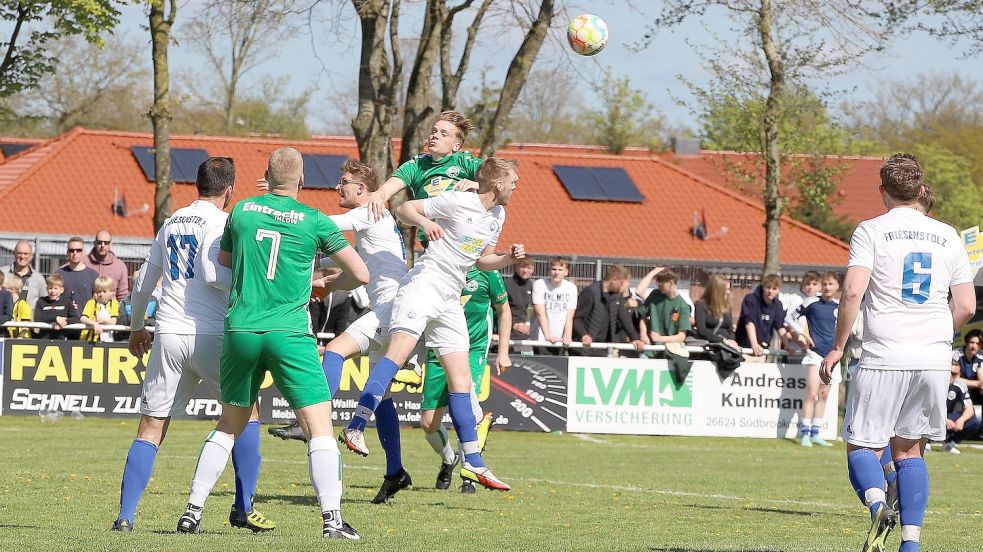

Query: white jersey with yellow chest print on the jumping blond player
[[413, 192, 505, 297]]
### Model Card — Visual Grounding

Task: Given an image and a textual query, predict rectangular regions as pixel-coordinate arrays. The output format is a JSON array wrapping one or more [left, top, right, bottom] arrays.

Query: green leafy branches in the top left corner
[[0, 0, 119, 97]]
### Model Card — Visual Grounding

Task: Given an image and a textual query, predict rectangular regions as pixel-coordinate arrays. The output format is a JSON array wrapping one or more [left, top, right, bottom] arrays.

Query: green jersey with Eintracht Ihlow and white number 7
[[221, 193, 348, 333]]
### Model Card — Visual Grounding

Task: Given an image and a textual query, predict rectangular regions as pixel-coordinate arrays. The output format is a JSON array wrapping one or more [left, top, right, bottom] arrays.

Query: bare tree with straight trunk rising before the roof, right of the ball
[[644, 0, 888, 273]]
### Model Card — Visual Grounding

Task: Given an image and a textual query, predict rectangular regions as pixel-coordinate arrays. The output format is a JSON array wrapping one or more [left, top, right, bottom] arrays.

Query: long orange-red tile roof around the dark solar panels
[[0, 129, 847, 266]]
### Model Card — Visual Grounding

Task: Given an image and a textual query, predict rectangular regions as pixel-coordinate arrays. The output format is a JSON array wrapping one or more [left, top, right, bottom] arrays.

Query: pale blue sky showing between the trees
[[120, 0, 979, 137]]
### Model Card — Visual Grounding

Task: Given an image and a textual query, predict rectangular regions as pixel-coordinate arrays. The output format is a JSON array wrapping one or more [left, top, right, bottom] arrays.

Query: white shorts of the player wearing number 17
[[140, 334, 222, 418]]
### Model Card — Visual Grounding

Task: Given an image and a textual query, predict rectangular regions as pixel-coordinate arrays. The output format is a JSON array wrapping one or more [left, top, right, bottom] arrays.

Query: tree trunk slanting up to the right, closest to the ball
[[481, 0, 555, 158]]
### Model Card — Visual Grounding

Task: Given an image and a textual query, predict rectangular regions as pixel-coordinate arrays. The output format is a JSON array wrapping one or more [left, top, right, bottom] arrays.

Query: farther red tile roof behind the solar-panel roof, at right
[[660, 151, 885, 223]]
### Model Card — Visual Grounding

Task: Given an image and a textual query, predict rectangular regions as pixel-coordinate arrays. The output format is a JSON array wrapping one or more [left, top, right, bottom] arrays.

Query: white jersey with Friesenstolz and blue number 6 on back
[[849, 207, 973, 370]]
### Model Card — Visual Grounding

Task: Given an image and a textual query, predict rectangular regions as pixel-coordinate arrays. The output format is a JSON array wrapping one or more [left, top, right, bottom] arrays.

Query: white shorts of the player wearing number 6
[[842, 367, 949, 448]]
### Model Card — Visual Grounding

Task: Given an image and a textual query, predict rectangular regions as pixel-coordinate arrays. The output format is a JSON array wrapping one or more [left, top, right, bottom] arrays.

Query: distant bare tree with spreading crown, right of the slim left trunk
[[185, 0, 295, 134]]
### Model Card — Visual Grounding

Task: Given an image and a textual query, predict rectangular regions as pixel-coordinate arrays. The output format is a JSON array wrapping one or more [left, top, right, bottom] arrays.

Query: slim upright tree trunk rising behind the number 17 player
[[150, 0, 177, 232]]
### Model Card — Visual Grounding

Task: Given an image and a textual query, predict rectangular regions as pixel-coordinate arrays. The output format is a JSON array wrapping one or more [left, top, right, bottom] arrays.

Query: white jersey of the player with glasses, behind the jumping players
[[329, 206, 407, 308]]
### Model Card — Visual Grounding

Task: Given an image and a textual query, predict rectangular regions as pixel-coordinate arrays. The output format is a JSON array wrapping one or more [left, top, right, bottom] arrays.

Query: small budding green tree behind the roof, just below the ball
[[592, 77, 662, 154]]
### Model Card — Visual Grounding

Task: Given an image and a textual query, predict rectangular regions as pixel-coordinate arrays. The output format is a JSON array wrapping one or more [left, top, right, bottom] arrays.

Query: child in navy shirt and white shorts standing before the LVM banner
[[796, 272, 840, 447]]
